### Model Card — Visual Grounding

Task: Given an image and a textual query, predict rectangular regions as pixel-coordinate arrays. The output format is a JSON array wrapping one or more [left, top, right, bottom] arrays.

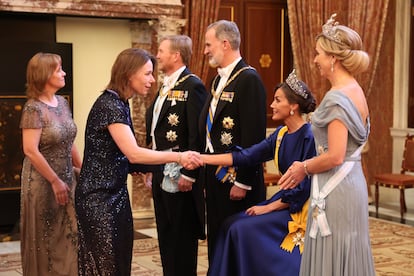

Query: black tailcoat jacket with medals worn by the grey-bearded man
[[199, 60, 266, 189]]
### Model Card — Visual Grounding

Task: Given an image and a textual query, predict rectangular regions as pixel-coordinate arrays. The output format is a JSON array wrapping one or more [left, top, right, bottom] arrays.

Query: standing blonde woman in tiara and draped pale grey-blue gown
[[279, 15, 375, 276]]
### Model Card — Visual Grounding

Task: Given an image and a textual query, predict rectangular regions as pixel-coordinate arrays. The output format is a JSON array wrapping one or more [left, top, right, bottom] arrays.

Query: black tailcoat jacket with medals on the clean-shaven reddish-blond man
[[146, 68, 207, 235]]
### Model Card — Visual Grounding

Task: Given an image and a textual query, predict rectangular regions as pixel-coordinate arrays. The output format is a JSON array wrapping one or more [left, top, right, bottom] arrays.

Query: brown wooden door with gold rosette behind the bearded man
[[212, 0, 293, 127]]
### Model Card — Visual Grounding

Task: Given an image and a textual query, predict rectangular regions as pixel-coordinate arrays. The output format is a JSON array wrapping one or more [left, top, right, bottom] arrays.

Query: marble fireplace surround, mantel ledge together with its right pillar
[[0, 0, 186, 218]]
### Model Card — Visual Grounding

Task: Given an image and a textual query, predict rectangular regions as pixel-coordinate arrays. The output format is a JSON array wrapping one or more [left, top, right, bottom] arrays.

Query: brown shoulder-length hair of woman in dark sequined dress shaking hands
[[106, 48, 155, 100]]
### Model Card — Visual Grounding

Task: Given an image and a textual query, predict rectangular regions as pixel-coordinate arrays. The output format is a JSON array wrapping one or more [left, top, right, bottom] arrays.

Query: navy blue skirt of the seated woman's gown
[[208, 196, 301, 276]]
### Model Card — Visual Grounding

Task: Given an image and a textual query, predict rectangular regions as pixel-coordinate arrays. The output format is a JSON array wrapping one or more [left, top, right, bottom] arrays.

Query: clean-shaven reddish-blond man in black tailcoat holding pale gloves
[[146, 35, 207, 276]]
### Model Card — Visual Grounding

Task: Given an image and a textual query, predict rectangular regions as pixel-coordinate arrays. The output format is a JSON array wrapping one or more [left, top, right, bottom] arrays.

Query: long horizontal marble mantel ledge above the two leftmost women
[[0, 0, 184, 19]]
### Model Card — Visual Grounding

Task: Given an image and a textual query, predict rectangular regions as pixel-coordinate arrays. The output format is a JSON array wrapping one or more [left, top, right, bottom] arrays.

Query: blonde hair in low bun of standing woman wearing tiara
[[316, 25, 369, 75]]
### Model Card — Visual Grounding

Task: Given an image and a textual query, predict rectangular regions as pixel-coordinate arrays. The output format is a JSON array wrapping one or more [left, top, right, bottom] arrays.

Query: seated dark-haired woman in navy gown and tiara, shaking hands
[[202, 71, 316, 276]]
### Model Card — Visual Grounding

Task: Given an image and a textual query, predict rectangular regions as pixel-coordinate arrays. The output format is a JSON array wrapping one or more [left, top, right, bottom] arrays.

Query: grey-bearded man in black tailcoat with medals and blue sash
[[200, 20, 266, 262]]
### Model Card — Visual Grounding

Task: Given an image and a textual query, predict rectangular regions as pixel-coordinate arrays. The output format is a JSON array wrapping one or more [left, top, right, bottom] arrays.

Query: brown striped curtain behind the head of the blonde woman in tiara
[[288, 0, 389, 102]]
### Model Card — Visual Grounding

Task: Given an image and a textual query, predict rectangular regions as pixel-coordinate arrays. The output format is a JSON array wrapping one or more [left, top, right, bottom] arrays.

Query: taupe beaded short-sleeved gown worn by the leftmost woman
[[20, 96, 78, 276]]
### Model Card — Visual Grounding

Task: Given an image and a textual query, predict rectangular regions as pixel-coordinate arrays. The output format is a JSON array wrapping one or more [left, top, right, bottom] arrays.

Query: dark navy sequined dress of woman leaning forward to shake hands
[[75, 90, 133, 276]]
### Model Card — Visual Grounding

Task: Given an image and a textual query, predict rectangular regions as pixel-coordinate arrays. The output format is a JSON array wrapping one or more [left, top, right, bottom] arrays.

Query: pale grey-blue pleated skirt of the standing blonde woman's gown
[[300, 162, 375, 276]]
